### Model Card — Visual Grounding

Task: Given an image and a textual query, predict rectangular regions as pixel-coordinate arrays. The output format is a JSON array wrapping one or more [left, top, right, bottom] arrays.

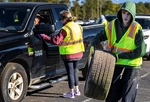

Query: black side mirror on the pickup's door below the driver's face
[[33, 24, 55, 35]]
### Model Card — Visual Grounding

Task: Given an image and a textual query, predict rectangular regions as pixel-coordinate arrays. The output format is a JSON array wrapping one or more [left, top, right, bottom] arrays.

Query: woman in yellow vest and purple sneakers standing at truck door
[[41, 10, 84, 98]]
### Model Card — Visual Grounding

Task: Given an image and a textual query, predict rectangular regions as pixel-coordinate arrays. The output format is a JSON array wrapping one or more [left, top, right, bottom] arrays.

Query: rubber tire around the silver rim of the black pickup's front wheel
[[1, 63, 28, 102]]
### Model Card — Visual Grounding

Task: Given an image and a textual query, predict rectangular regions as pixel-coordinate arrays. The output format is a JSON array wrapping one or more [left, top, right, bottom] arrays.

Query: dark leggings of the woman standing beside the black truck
[[64, 60, 79, 89]]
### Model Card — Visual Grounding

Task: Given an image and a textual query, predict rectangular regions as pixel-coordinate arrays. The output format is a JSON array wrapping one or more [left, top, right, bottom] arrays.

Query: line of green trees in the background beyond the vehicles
[[0, 0, 150, 21]]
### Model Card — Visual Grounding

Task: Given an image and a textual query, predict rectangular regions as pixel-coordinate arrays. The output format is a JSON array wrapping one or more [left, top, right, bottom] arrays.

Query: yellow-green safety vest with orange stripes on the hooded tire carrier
[[105, 20, 142, 67]]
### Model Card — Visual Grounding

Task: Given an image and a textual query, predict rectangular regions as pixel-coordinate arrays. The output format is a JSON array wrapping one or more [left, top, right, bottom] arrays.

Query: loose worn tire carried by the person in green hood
[[84, 50, 116, 100]]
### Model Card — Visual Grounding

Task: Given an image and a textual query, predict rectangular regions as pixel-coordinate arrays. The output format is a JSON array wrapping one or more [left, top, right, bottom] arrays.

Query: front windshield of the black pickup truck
[[0, 6, 31, 31]]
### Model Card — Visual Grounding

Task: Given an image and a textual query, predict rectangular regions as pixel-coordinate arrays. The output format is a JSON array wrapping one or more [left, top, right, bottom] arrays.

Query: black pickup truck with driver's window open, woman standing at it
[[0, 2, 103, 102]]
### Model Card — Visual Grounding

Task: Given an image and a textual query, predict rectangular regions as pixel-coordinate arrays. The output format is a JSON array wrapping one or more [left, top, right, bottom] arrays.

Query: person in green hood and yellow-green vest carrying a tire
[[92, 1, 145, 102]]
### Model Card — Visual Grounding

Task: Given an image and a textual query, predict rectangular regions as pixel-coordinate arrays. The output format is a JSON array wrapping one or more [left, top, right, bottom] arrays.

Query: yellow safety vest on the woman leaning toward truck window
[[59, 22, 84, 55]]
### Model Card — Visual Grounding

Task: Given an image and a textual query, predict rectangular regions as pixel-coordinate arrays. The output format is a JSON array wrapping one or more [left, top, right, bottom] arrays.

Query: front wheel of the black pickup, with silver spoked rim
[[0, 62, 28, 102]]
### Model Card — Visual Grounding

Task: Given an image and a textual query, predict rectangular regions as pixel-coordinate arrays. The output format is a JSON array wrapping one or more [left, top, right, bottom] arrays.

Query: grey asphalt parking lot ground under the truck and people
[[23, 61, 150, 102]]
